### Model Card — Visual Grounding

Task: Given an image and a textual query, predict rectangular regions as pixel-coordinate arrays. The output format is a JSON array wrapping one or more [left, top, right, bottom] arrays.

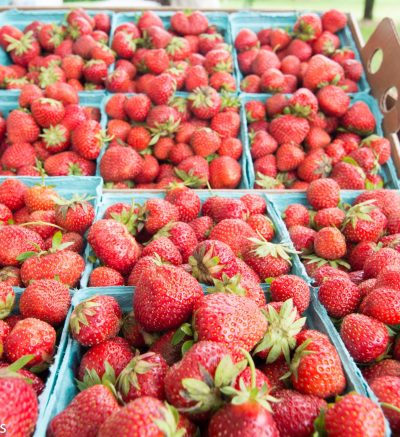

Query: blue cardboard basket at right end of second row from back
[[240, 93, 399, 192]]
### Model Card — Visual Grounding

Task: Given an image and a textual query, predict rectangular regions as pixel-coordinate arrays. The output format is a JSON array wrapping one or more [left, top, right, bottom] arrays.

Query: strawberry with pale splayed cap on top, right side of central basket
[[243, 238, 294, 281]]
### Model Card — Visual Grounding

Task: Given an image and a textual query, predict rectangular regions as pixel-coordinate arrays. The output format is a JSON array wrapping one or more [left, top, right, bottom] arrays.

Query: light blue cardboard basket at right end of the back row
[[229, 11, 370, 93]]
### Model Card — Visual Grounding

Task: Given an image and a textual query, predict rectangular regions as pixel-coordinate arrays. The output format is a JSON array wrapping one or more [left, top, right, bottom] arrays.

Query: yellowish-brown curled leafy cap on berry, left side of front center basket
[[117, 351, 160, 396]]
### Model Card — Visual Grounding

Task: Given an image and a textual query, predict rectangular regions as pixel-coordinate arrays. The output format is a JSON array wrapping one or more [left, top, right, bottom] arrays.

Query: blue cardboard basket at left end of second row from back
[[0, 90, 107, 178]]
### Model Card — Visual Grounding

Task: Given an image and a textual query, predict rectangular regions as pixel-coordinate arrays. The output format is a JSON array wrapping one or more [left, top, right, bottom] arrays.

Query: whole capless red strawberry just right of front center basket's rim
[[340, 314, 389, 363]]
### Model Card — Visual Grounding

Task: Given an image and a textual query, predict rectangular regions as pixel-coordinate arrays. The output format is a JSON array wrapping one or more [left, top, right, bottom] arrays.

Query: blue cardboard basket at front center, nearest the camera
[[38, 287, 390, 436]]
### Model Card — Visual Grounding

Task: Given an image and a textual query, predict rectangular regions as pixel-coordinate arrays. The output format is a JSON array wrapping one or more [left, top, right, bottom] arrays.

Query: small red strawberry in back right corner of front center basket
[[270, 275, 310, 314]]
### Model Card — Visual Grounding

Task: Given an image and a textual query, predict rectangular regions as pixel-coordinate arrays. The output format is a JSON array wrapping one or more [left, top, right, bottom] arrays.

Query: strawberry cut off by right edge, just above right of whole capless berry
[[362, 287, 400, 325]]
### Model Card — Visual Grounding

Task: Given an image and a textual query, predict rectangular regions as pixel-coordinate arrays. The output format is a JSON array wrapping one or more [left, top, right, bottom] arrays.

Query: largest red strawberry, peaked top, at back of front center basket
[[133, 265, 203, 332]]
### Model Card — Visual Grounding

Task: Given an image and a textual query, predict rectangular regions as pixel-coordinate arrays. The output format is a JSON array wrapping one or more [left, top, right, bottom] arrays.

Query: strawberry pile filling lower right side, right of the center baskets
[[284, 179, 400, 432]]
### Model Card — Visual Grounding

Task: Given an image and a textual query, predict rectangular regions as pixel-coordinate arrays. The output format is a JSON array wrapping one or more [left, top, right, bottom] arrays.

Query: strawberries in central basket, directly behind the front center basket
[[88, 184, 309, 290]]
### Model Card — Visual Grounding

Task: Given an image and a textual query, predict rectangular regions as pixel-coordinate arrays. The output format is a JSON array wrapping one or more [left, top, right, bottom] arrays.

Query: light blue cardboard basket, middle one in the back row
[[109, 8, 240, 95]]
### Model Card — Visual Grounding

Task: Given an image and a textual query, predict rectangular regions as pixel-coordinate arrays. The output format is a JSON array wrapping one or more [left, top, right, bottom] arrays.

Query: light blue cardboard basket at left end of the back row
[[0, 9, 115, 97]]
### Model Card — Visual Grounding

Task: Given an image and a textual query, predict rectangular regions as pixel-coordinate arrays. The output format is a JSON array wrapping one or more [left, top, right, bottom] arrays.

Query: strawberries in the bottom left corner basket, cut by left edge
[[0, 279, 71, 436]]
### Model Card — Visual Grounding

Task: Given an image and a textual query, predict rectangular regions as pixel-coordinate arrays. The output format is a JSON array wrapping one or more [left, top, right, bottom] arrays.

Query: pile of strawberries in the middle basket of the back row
[[106, 11, 236, 93]]
